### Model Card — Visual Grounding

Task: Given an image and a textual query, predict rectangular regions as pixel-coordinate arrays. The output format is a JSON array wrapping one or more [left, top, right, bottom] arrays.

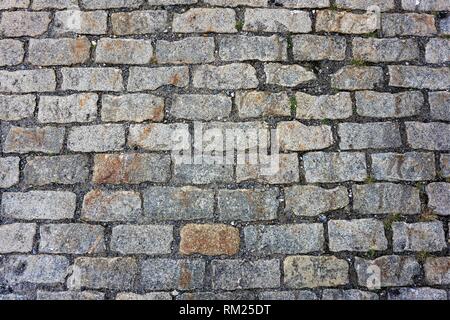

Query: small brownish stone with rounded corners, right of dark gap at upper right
[[331, 66, 383, 91]]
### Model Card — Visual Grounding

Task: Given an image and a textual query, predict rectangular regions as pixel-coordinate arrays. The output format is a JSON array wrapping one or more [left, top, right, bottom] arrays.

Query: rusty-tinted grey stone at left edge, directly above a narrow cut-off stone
[[3, 126, 64, 154]]
